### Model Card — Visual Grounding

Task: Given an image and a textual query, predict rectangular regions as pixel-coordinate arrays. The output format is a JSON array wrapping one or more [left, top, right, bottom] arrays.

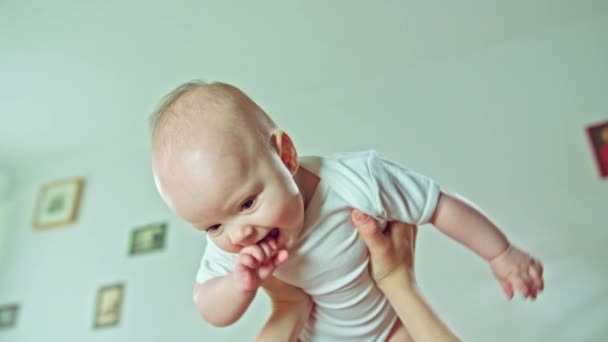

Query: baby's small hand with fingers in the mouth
[[235, 238, 287, 291]]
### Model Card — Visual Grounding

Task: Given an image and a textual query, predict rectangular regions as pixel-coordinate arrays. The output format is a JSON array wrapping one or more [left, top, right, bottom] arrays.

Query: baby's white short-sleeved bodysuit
[[196, 151, 440, 341]]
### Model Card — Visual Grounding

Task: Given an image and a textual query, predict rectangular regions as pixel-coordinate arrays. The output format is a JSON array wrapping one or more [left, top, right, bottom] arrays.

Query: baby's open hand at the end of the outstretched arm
[[490, 245, 544, 299]]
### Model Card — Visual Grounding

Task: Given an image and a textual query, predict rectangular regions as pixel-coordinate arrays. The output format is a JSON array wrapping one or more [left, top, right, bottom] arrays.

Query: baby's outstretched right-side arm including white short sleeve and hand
[[367, 154, 543, 298]]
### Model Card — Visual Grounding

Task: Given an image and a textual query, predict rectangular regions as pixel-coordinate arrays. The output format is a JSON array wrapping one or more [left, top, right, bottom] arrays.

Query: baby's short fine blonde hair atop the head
[[150, 80, 277, 152]]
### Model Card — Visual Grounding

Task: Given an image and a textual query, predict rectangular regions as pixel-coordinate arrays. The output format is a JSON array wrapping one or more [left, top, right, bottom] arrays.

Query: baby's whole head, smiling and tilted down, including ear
[[151, 82, 304, 252]]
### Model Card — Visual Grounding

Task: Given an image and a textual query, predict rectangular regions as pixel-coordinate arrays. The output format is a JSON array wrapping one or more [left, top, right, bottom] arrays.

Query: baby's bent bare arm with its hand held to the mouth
[[194, 239, 287, 326]]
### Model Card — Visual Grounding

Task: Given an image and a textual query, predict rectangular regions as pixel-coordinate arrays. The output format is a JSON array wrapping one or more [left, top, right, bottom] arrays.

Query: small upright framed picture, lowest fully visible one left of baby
[[93, 283, 124, 329]]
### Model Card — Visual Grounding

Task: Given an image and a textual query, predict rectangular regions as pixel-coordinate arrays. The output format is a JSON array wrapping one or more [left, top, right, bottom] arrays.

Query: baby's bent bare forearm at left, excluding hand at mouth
[[194, 275, 256, 327]]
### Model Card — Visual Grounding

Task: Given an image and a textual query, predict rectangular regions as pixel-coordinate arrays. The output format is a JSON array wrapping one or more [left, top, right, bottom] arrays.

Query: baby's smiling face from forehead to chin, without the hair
[[154, 135, 304, 253]]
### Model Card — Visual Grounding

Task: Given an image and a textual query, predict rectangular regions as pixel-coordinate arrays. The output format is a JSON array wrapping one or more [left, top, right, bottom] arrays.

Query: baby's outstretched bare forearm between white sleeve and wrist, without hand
[[431, 193, 509, 260]]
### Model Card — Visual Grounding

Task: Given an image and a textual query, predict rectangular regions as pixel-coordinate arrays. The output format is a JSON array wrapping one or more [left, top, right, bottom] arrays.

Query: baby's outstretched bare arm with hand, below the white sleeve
[[431, 192, 544, 299]]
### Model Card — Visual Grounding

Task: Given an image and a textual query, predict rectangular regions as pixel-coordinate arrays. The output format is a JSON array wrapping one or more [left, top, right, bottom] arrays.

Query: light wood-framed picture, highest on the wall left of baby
[[34, 178, 84, 229]]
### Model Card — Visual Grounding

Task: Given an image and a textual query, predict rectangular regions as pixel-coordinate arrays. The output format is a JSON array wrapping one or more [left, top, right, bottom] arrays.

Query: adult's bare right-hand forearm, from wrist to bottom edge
[[378, 267, 459, 342]]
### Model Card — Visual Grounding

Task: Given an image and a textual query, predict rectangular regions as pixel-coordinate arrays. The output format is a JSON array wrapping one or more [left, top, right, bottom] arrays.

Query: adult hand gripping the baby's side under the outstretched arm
[[351, 209, 418, 283]]
